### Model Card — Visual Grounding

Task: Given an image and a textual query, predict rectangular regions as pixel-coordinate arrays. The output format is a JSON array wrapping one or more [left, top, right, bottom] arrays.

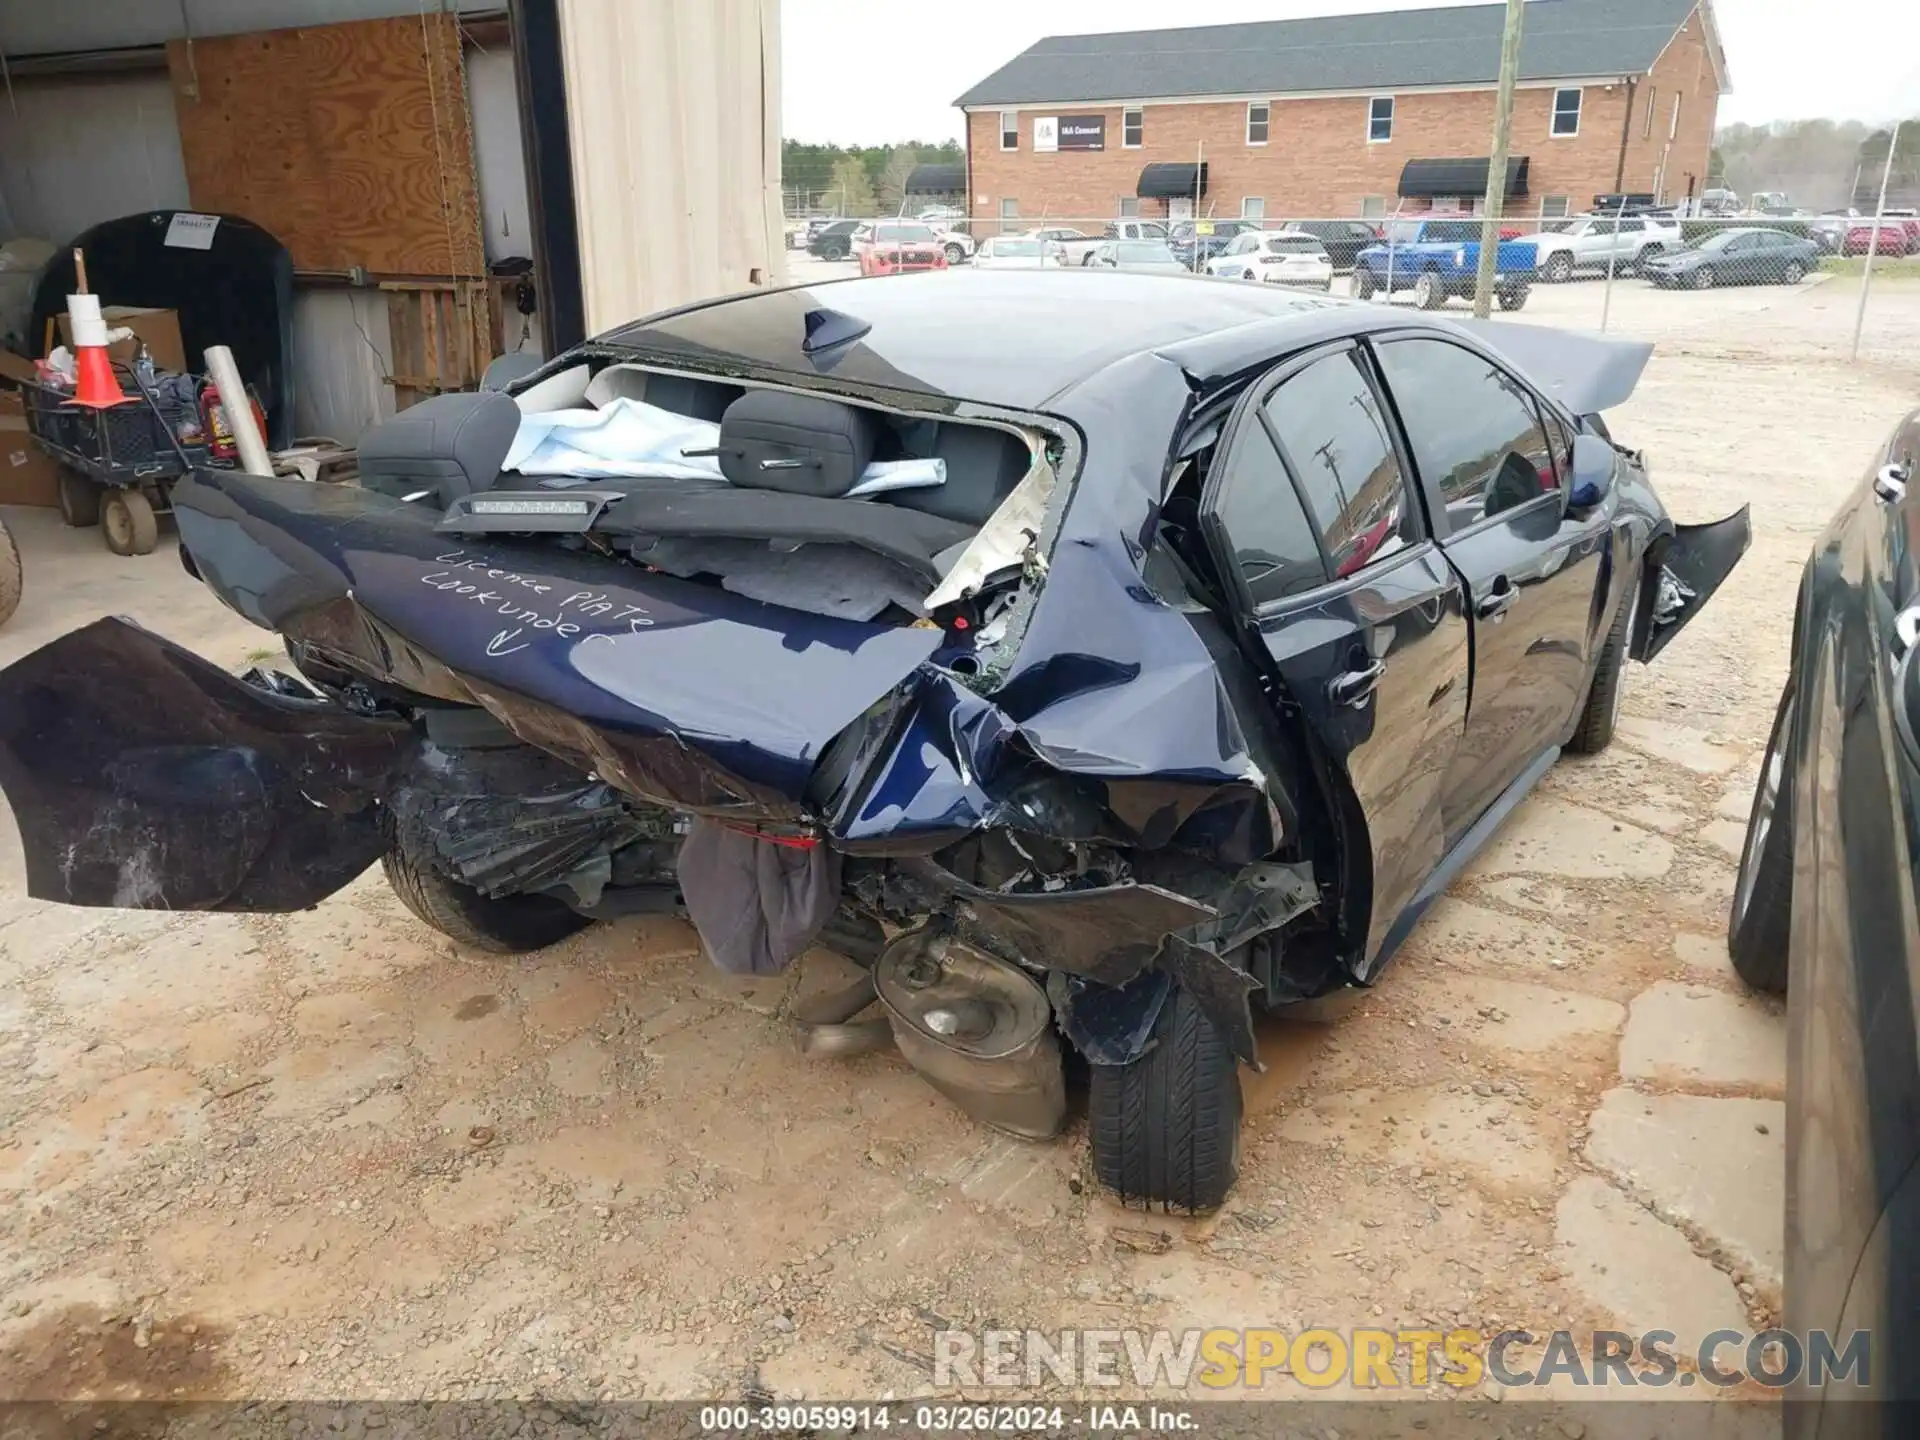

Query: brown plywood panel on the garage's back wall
[[167, 13, 482, 275]]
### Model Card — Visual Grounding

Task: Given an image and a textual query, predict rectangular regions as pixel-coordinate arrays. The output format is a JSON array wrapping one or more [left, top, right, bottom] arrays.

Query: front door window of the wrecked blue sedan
[[1379, 340, 1557, 530]]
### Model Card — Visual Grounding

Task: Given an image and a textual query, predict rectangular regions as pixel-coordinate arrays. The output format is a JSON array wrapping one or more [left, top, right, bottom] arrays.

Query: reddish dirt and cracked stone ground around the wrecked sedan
[[0, 267, 1920, 1413]]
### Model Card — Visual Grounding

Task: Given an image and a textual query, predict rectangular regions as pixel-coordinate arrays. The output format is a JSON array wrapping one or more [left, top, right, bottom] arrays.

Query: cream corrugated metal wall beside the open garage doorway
[[561, 0, 785, 332]]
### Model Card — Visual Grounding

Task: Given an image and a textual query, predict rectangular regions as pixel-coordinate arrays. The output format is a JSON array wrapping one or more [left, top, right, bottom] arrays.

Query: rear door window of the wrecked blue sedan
[[1263, 351, 1417, 580]]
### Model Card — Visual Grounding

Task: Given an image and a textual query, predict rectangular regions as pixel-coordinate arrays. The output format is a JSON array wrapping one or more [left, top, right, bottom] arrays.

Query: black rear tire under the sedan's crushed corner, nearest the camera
[[1087, 987, 1240, 1213]]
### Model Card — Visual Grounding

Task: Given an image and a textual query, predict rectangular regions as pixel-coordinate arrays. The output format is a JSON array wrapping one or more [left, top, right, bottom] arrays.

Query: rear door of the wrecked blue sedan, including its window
[[1202, 342, 1469, 968]]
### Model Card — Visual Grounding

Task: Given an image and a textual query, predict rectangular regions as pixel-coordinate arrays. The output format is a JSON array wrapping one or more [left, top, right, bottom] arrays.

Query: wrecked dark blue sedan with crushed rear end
[[0, 271, 1749, 1210]]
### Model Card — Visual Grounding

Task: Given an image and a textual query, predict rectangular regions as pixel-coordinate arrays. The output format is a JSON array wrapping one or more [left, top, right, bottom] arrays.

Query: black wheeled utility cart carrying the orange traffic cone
[[21, 365, 211, 555]]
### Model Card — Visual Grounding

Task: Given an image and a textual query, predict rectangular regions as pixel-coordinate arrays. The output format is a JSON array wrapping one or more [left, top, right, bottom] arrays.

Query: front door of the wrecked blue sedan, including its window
[[1375, 334, 1611, 845]]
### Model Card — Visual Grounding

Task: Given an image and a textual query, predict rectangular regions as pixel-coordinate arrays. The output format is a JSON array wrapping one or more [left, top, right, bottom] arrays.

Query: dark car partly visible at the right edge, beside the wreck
[[1728, 411, 1920, 1440]]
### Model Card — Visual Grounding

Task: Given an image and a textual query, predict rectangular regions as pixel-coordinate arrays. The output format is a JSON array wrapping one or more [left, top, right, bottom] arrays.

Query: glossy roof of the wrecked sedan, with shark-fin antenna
[[597, 267, 1351, 409]]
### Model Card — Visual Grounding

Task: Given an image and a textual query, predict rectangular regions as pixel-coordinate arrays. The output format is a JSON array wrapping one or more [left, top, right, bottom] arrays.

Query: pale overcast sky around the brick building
[[780, 0, 1920, 144]]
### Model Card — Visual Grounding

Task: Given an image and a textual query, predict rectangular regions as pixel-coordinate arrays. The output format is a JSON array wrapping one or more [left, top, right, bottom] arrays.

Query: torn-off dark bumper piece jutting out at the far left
[[0, 618, 413, 912]]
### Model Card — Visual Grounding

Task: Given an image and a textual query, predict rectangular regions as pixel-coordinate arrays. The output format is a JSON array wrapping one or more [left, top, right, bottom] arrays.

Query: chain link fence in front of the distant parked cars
[[789, 205, 1920, 376]]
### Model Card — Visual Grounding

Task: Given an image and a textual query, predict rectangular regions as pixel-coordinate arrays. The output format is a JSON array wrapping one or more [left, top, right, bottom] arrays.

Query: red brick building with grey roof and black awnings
[[954, 0, 1728, 228]]
